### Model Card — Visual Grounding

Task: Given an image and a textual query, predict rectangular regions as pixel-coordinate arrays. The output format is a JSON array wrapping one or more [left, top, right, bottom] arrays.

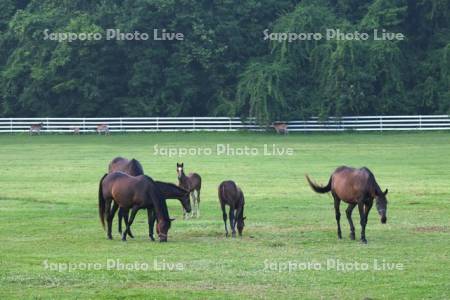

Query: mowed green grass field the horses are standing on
[[0, 132, 450, 299]]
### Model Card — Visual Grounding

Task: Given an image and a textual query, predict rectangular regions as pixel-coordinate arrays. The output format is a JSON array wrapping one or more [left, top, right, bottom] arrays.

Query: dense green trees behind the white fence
[[0, 0, 450, 123]]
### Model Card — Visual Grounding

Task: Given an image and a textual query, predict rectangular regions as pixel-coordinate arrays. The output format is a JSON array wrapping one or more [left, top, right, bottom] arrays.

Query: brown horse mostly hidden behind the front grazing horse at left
[[108, 156, 191, 241]]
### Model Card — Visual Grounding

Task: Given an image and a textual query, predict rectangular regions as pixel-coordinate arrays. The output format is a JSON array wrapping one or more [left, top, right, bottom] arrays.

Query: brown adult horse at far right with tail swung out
[[306, 166, 388, 243]]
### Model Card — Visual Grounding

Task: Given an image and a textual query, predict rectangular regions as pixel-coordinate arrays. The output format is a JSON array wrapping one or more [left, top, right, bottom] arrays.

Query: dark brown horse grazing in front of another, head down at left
[[98, 172, 173, 242]]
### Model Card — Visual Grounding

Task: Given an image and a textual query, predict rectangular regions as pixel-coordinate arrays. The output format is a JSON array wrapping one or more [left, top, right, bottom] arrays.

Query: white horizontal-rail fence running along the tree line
[[0, 115, 450, 133]]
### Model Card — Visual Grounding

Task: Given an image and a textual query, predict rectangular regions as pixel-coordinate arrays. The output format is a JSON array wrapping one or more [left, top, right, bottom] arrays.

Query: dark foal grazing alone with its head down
[[219, 180, 246, 237]]
